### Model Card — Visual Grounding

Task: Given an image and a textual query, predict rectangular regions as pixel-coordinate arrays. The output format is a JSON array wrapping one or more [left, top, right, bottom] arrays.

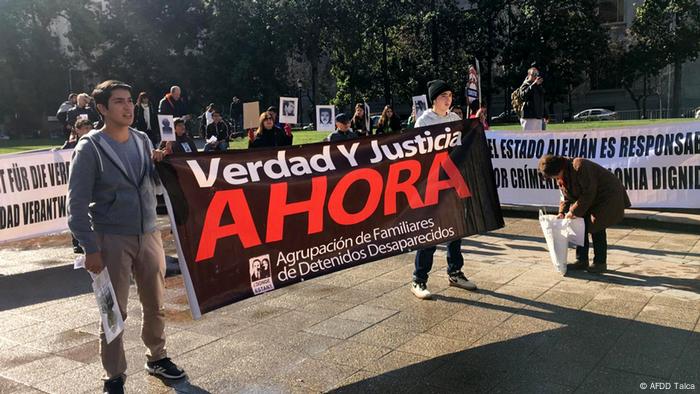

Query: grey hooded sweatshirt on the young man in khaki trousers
[[68, 128, 160, 253]]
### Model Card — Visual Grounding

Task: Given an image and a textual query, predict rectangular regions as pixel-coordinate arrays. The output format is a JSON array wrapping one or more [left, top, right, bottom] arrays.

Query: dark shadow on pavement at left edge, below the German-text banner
[[0, 264, 92, 311]]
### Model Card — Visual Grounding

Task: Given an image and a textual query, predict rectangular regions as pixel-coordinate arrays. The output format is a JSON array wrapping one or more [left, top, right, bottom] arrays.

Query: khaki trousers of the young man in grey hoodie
[[97, 231, 167, 379]]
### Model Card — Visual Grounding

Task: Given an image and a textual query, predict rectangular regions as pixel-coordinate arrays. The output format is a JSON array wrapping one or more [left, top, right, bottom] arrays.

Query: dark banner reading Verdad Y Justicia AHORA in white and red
[[158, 120, 503, 317]]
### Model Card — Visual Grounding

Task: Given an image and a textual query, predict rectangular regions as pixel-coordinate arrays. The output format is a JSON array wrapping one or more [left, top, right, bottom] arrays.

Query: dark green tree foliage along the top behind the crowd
[[6, 0, 700, 135]]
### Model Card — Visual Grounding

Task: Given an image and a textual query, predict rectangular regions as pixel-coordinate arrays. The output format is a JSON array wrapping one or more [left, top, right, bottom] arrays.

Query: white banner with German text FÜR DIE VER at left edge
[[0, 149, 73, 243]]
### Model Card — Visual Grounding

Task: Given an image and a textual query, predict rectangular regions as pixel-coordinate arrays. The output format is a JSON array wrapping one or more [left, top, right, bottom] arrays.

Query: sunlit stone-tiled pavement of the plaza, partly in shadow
[[0, 218, 700, 394]]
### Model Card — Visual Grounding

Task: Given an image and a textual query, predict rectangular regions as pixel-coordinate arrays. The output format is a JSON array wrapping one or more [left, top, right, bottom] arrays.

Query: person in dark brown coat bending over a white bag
[[539, 155, 631, 273]]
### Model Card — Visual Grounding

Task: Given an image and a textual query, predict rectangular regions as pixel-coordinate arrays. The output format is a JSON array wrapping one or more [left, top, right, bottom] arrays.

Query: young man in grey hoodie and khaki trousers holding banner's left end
[[68, 80, 185, 393]]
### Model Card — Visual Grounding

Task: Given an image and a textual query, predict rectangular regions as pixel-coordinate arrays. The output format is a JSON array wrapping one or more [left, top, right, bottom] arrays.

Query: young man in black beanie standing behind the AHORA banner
[[411, 79, 476, 299]]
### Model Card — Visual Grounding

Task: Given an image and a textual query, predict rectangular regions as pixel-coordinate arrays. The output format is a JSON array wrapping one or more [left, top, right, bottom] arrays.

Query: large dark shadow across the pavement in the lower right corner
[[332, 290, 700, 393]]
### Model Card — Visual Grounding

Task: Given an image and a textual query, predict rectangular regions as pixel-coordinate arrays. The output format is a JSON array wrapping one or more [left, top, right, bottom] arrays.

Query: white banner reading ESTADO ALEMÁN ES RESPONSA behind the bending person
[[487, 122, 700, 208]]
